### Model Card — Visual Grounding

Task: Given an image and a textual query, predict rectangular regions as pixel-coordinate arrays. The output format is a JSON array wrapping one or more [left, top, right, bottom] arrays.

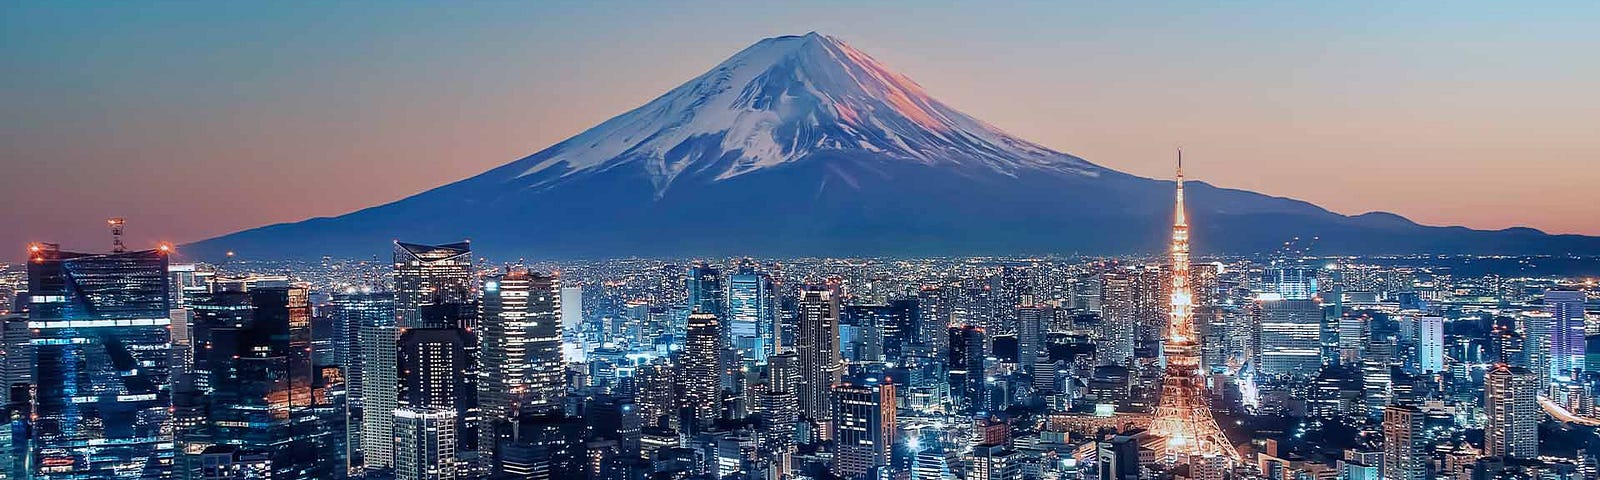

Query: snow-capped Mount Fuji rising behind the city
[[186, 32, 1600, 258]]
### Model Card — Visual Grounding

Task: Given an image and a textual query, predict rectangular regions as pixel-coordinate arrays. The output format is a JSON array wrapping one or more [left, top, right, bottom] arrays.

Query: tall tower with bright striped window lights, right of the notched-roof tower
[[478, 269, 566, 466]]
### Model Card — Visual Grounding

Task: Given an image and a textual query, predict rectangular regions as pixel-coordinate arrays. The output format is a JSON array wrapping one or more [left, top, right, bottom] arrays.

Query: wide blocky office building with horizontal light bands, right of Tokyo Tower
[[1256, 294, 1322, 378]]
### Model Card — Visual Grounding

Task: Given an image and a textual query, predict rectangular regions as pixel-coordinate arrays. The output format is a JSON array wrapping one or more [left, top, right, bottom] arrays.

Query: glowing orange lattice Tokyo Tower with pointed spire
[[1150, 150, 1240, 462]]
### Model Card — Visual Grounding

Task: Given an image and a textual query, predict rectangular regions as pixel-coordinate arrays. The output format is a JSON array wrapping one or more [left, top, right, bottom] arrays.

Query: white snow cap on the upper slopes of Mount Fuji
[[512, 32, 1104, 197]]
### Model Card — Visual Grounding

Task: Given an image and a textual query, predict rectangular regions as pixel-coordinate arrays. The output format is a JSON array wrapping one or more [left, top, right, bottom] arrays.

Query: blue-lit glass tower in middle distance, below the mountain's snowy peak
[[726, 266, 778, 362]]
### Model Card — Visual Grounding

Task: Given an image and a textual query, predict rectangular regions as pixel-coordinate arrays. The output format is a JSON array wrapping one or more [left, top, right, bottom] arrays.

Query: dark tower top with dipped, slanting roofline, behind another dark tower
[[394, 242, 474, 328]]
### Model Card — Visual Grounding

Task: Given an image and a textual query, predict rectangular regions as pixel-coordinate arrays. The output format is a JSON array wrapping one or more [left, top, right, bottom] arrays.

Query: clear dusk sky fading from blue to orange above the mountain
[[0, 2, 1600, 258]]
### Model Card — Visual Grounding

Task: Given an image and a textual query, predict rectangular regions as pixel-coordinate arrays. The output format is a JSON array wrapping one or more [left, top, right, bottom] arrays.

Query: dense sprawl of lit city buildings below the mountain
[[0, 173, 1600, 480]]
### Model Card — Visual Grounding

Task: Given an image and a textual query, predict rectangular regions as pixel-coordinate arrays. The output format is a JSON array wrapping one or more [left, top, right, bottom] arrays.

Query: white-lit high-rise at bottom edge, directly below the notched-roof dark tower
[[394, 406, 462, 480]]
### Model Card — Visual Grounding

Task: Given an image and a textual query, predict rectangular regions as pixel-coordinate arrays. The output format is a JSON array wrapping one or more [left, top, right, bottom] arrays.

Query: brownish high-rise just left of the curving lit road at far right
[[1483, 363, 1542, 459]]
